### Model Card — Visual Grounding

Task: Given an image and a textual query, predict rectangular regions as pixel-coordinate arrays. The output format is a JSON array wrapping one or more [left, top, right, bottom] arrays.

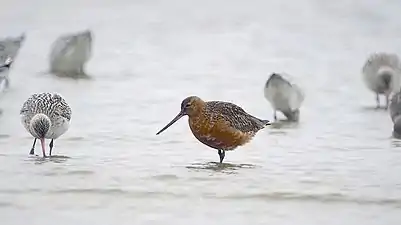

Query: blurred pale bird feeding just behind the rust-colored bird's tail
[[264, 73, 305, 121]]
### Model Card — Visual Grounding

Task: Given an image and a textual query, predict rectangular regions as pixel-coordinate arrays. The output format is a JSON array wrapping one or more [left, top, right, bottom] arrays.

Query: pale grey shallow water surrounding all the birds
[[0, 0, 401, 225]]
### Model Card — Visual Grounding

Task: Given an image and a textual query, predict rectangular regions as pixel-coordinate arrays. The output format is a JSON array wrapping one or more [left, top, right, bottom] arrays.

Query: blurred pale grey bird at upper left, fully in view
[[49, 30, 93, 76]]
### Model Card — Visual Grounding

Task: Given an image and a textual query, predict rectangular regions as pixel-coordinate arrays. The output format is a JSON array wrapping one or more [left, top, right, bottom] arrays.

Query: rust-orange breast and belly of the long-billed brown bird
[[189, 114, 254, 151]]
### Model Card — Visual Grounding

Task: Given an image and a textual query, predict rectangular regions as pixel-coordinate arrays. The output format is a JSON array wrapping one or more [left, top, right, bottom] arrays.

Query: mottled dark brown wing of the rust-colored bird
[[206, 101, 268, 133]]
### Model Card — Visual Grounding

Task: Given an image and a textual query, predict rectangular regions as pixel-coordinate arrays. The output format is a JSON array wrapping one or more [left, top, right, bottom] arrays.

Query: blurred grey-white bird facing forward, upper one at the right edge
[[362, 52, 401, 109]]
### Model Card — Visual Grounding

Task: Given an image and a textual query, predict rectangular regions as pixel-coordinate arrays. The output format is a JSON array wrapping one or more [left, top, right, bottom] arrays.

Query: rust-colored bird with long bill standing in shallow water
[[156, 96, 270, 163]]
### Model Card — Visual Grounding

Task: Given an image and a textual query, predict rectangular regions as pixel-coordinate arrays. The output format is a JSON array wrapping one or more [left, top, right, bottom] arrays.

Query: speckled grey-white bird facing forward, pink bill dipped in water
[[20, 93, 72, 157]]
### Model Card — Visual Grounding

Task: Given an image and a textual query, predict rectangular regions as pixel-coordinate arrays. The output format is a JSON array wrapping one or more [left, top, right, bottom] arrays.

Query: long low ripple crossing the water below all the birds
[[0, 188, 401, 208]]
